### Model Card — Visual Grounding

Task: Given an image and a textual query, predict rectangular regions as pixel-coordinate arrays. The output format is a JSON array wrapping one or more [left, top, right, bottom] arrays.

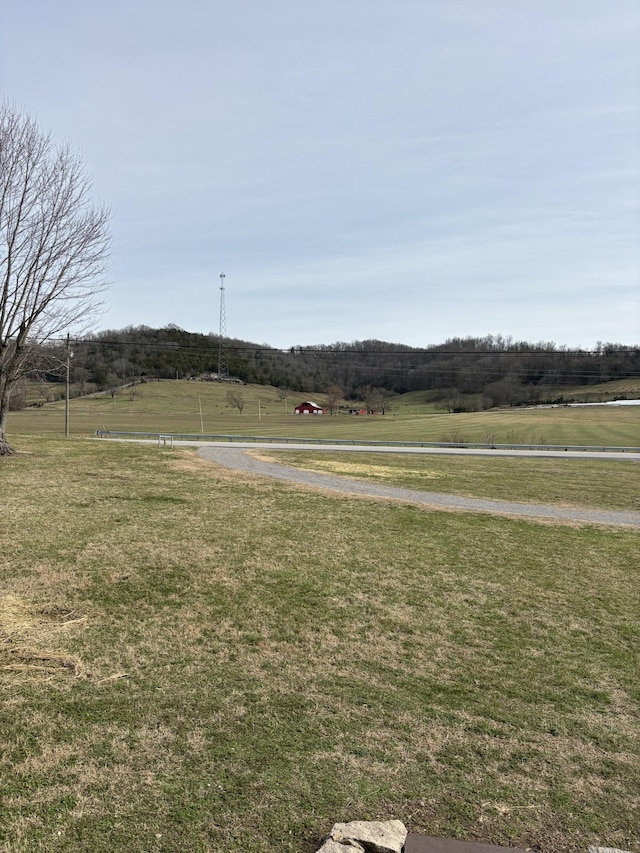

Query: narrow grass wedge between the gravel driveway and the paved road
[[254, 449, 640, 511]]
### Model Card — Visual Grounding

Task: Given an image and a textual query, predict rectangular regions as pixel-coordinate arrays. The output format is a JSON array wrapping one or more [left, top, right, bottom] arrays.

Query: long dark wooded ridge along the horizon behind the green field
[[51, 326, 640, 405]]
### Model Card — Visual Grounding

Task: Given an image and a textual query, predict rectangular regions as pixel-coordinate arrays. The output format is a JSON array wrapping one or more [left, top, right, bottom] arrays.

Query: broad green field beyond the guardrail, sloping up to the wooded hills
[[9, 381, 640, 446]]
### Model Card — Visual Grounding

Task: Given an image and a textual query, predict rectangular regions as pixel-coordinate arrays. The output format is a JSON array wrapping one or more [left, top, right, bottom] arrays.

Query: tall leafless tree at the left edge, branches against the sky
[[0, 103, 109, 456]]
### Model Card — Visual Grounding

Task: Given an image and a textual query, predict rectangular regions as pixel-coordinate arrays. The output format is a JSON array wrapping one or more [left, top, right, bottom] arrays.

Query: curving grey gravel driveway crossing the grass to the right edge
[[198, 445, 640, 528]]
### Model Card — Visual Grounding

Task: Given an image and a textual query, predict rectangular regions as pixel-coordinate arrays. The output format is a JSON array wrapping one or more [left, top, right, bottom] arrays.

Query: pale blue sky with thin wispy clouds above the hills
[[0, 0, 640, 347]]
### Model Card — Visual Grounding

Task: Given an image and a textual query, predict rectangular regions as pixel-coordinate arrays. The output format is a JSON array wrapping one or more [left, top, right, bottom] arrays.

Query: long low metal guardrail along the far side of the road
[[96, 429, 640, 453]]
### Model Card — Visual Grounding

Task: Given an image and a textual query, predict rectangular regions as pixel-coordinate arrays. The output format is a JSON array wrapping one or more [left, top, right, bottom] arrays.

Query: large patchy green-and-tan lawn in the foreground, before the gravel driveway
[[0, 438, 640, 853]]
